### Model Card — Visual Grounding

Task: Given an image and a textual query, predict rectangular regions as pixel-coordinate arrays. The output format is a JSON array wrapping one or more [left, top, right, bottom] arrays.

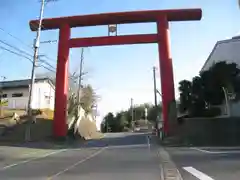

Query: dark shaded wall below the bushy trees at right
[[177, 117, 240, 146]]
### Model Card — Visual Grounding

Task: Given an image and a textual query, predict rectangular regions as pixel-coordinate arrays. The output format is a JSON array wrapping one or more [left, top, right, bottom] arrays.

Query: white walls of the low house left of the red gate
[[0, 78, 55, 110]]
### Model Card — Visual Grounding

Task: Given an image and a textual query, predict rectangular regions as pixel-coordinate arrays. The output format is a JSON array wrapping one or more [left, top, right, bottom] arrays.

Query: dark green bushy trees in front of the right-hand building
[[179, 62, 240, 116]]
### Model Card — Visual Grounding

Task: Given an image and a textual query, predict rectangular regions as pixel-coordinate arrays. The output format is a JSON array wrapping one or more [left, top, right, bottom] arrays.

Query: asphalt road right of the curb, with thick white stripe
[[166, 147, 240, 180]]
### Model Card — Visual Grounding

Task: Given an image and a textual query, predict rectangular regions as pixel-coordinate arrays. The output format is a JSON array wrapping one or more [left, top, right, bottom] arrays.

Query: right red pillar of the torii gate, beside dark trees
[[157, 15, 177, 136]]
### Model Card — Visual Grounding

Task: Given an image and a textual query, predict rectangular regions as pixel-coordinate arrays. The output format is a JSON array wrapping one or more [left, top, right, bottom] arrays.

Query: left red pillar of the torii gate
[[53, 24, 71, 137]]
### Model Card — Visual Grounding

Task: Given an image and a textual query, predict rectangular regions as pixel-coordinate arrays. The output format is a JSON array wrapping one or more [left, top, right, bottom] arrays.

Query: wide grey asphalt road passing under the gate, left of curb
[[0, 133, 160, 180]]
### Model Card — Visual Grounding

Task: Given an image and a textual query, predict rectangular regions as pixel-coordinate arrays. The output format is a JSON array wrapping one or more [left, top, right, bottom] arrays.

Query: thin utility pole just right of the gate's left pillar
[[77, 48, 84, 117]]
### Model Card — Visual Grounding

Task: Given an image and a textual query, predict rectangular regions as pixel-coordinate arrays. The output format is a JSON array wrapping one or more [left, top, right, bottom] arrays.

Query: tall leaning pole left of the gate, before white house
[[25, 0, 45, 141]]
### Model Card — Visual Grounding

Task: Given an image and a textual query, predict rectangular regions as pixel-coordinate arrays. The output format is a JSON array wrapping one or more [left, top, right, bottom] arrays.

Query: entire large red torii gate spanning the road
[[30, 9, 202, 137]]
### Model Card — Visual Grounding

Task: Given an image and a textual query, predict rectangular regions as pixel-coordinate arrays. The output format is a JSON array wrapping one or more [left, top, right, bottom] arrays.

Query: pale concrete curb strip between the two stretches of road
[[159, 147, 183, 180]]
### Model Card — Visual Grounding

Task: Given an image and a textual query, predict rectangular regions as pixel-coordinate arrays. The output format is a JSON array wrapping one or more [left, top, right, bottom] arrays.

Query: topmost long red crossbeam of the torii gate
[[30, 9, 202, 31]]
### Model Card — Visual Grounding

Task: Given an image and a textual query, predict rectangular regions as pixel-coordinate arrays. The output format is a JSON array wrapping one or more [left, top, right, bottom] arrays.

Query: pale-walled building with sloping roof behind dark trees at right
[[201, 36, 240, 116]]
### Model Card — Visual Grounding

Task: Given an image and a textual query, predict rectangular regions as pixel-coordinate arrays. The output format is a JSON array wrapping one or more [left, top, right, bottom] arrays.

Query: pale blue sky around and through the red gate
[[0, 0, 240, 129]]
